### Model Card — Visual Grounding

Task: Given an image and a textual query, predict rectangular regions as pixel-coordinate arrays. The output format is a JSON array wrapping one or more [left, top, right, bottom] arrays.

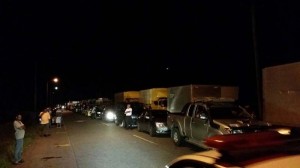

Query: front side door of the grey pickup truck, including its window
[[191, 105, 209, 141]]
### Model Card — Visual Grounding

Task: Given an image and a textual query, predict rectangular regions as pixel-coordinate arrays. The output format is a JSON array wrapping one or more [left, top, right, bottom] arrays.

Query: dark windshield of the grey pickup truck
[[210, 106, 251, 119]]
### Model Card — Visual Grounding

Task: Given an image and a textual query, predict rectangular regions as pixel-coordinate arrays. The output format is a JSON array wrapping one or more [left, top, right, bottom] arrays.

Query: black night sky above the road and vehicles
[[0, 0, 300, 114]]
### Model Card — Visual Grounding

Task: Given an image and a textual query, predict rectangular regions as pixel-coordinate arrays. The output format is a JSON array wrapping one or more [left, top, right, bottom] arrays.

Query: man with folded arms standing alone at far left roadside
[[13, 114, 25, 165]]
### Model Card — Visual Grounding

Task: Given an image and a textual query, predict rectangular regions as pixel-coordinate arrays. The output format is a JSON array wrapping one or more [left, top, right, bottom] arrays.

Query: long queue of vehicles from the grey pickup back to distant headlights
[[69, 84, 278, 148]]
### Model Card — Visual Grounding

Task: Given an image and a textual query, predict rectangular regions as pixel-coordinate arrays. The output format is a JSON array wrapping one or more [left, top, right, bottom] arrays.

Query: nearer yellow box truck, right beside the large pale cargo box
[[140, 88, 168, 109]]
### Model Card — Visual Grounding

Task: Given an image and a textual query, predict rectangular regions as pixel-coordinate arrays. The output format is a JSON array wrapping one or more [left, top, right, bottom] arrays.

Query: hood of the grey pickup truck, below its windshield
[[214, 119, 271, 128]]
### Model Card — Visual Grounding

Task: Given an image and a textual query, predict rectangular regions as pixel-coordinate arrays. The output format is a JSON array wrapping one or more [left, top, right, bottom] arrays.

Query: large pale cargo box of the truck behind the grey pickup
[[167, 84, 239, 113]]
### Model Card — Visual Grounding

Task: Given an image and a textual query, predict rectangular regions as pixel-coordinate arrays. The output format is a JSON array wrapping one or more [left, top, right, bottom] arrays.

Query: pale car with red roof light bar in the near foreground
[[165, 128, 300, 168]]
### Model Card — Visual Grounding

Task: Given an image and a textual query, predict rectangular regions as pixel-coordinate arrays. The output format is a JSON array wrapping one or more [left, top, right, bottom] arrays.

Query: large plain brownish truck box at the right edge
[[262, 62, 300, 127]]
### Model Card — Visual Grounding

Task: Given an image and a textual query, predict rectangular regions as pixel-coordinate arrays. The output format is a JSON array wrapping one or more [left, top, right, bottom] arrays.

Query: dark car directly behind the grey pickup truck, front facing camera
[[137, 109, 170, 136]]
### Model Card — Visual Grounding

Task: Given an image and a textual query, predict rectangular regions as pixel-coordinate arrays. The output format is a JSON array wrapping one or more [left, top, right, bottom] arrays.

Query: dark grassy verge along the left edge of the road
[[0, 122, 38, 168]]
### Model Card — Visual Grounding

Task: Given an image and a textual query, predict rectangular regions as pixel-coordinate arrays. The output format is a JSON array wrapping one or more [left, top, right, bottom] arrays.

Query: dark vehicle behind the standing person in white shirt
[[115, 102, 145, 127]]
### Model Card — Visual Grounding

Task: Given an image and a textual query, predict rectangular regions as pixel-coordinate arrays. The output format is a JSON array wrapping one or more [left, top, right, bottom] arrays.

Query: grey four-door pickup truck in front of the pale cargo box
[[167, 99, 272, 148]]
